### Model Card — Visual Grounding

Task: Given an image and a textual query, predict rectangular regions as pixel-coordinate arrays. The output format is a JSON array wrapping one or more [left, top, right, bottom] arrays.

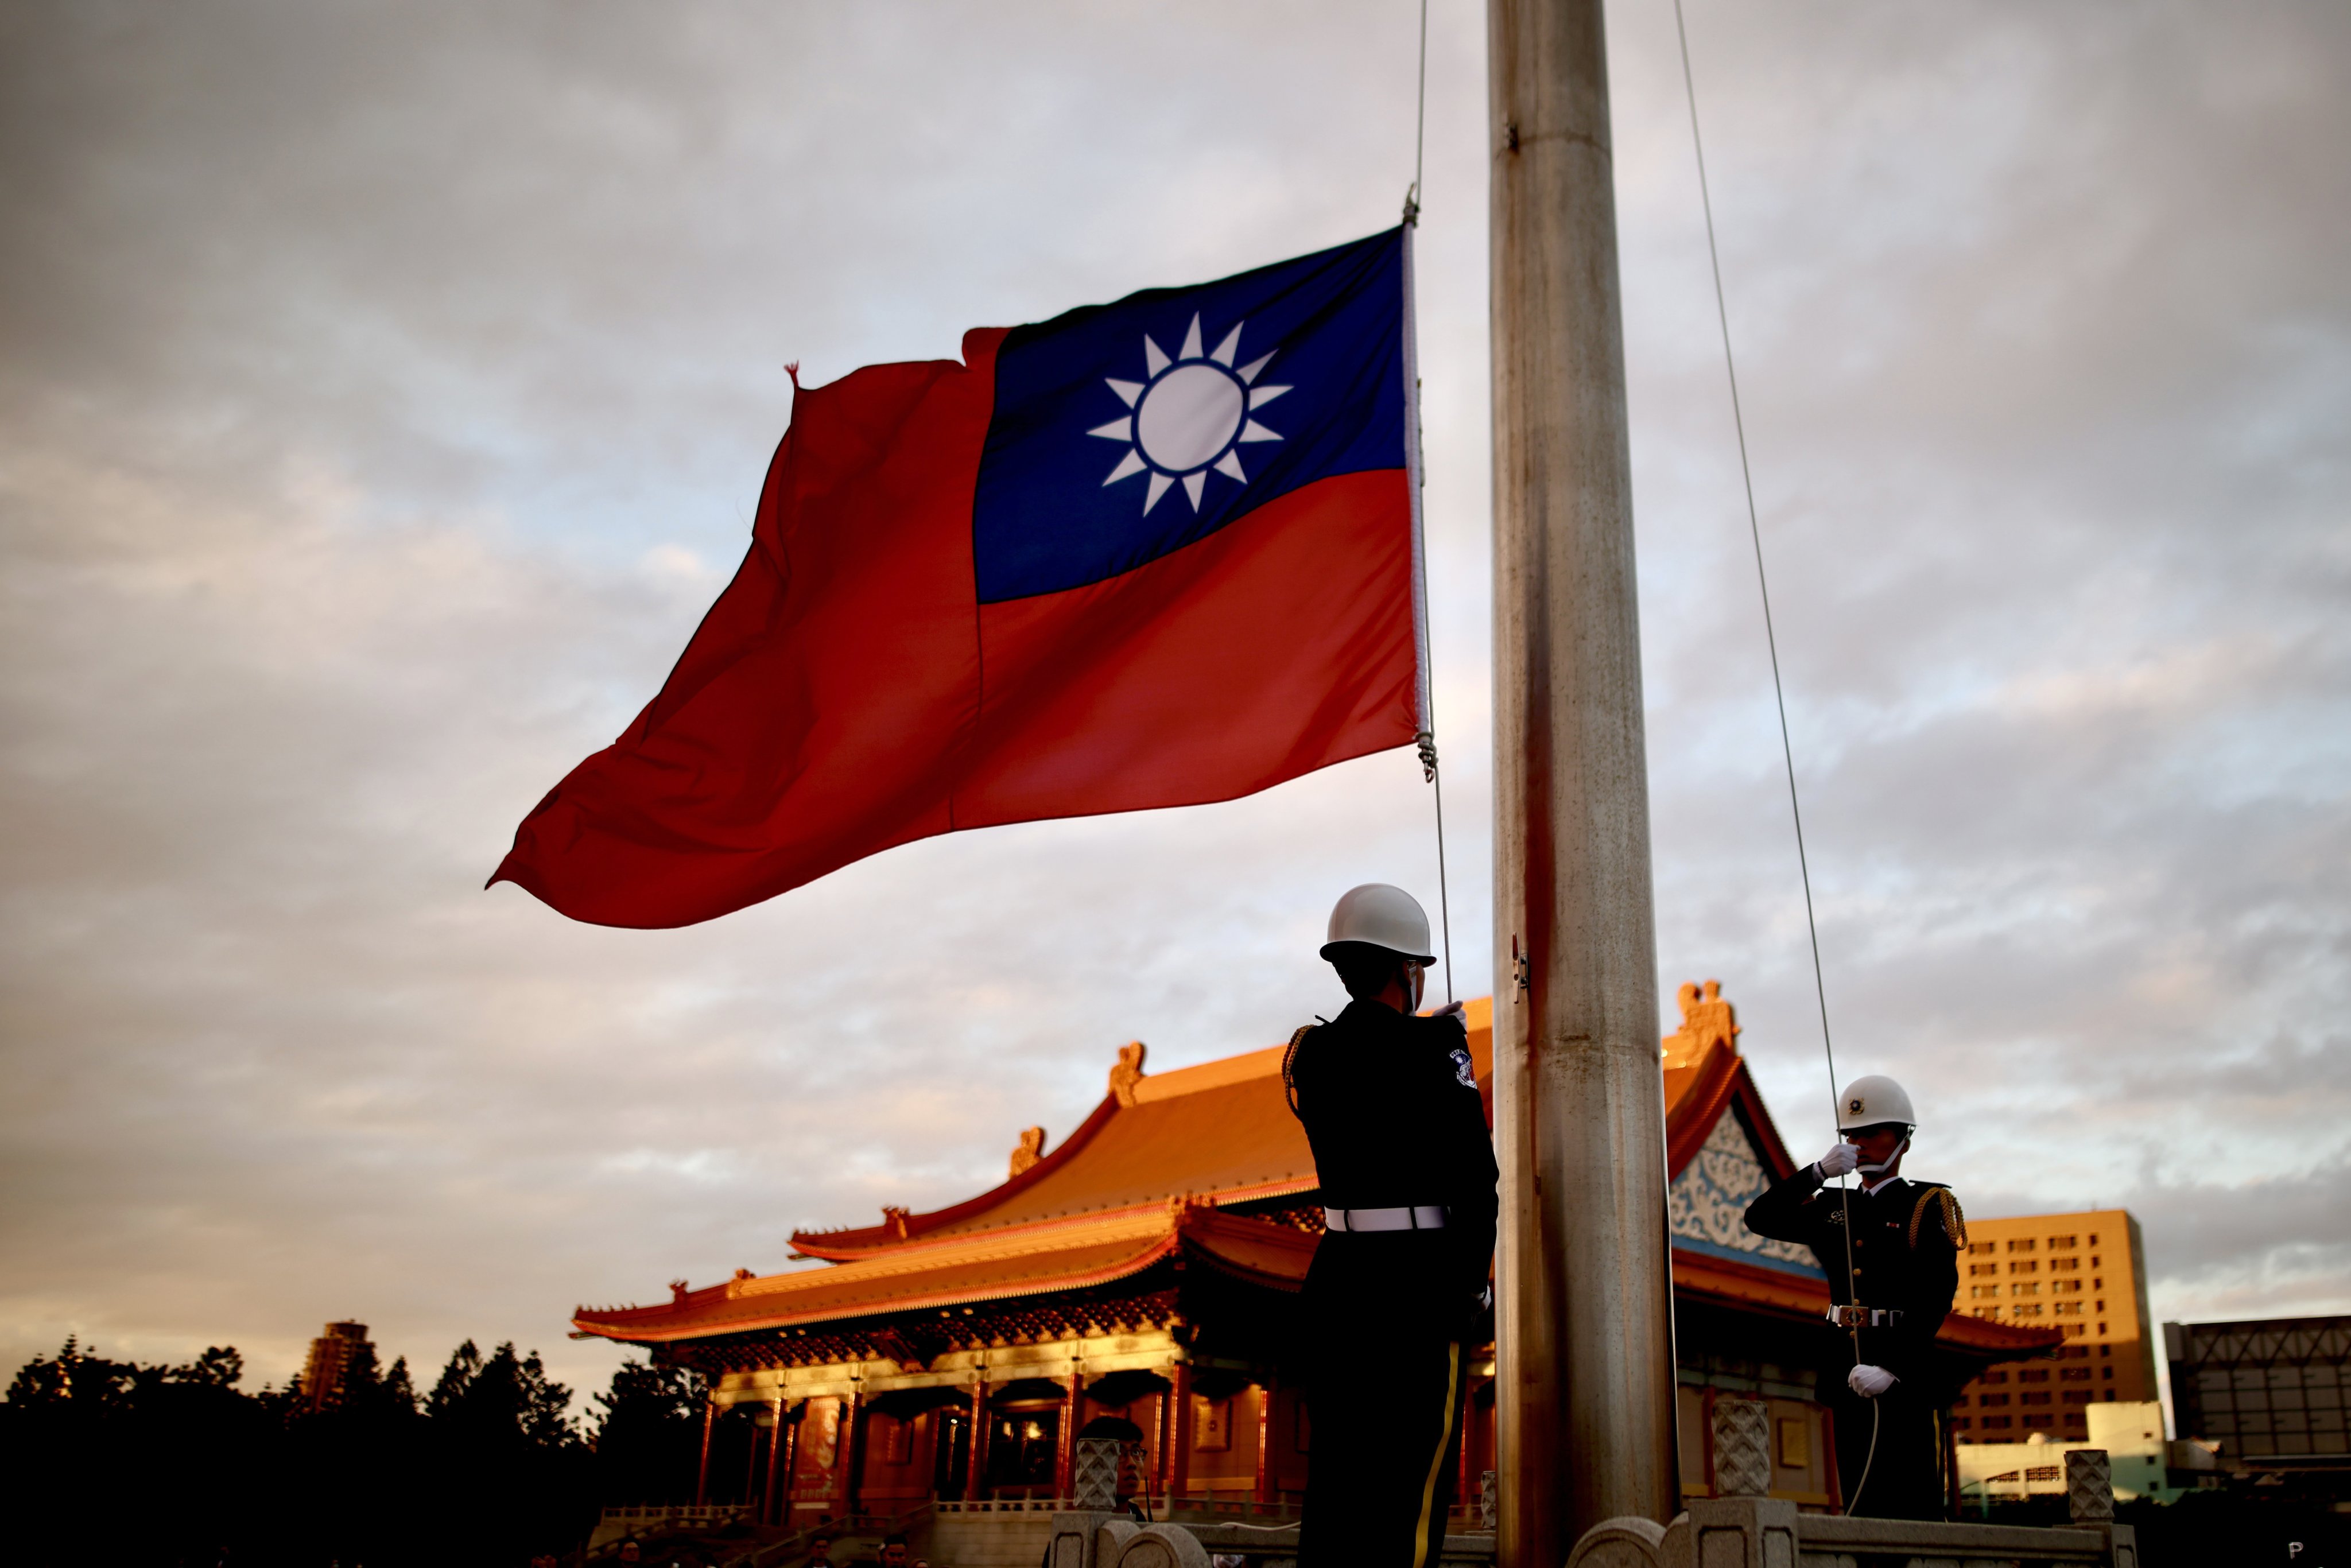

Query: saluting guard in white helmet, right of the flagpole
[[1747, 1077, 1968, 1519]]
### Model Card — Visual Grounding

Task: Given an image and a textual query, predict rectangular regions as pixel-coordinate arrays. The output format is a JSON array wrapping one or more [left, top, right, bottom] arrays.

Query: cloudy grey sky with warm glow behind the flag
[[0, 0, 2351, 1419]]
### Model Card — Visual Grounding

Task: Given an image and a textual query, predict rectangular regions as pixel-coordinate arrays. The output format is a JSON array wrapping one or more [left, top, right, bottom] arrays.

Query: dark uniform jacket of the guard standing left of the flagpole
[[1283, 1002, 1500, 1336]]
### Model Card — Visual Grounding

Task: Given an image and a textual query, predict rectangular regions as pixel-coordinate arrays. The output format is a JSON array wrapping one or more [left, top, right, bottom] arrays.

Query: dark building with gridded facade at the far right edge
[[2163, 1317, 2351, 1472]]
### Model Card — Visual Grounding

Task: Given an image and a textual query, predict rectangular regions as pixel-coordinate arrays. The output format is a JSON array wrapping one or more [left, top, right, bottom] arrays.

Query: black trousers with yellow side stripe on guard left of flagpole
[[1298, 1321, 1469, 1568]]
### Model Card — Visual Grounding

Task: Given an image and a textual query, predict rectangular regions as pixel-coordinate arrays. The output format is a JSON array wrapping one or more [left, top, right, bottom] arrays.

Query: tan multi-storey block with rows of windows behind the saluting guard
[[1952, 1208, 2156, 1443]]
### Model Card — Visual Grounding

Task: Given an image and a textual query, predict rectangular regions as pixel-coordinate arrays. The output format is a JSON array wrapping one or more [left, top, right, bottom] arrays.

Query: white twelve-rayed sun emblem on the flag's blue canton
[[1086, 315, 1291, 517]]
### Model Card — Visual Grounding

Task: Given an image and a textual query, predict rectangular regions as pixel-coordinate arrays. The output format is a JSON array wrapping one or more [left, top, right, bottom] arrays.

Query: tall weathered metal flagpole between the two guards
[[1486, 0, 1679, 1568]]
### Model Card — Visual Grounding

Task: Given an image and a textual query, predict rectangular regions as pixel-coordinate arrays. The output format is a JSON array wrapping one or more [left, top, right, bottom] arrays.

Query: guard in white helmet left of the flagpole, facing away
[[1281, 882, 1500, 1568]]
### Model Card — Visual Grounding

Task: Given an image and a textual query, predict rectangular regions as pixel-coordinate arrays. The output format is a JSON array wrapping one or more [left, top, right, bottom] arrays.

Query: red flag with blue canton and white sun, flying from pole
[[491, 228, 1425, 926]]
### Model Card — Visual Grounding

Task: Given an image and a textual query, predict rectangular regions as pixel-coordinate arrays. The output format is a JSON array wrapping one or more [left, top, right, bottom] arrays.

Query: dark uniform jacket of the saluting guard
[[1747, 1166, 1968, 1399]]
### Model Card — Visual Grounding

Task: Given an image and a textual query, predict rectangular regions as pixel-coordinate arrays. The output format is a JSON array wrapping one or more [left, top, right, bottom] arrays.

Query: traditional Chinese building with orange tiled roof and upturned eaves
[[573, 980, 2057, 1523]]
